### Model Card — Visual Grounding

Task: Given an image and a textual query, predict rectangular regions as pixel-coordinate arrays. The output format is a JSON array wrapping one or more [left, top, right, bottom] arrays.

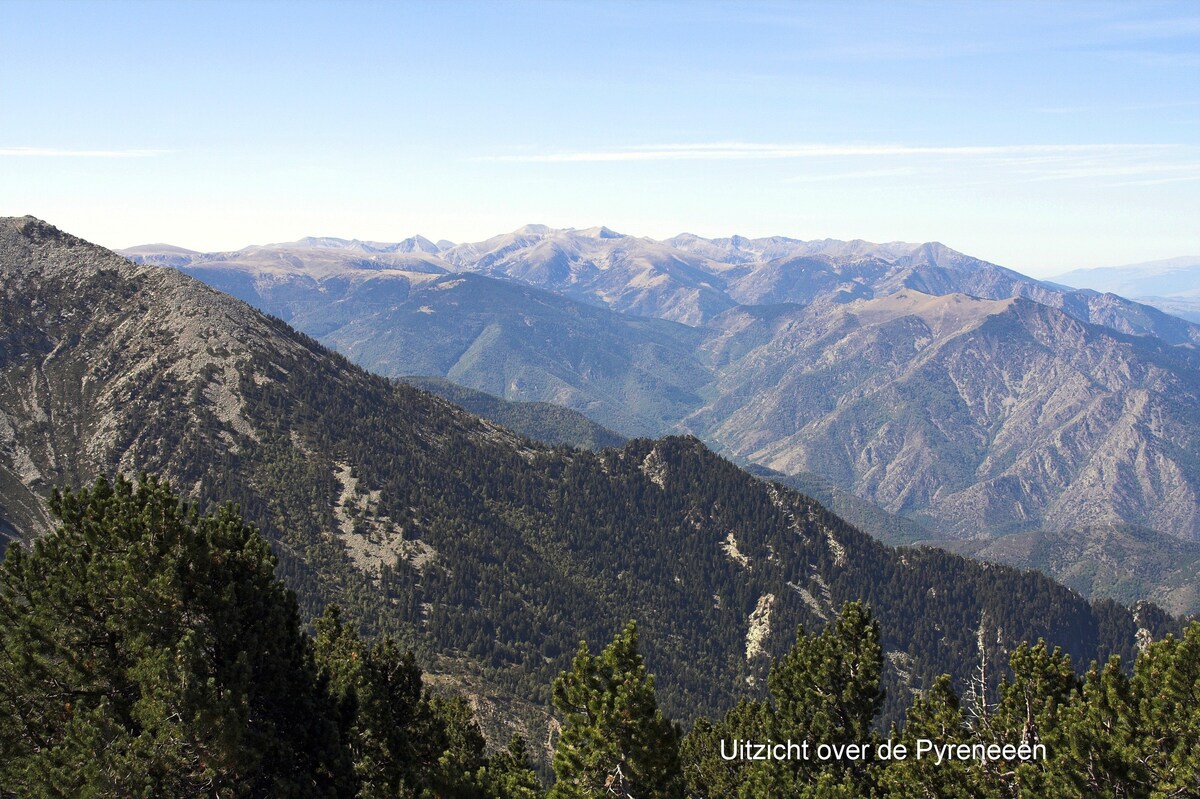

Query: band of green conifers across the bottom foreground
[[7, 476, 1200, 799]]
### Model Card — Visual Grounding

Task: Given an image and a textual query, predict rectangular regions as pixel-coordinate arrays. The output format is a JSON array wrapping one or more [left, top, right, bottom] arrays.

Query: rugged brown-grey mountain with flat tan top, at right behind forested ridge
[[688, 292, 1200, 539]]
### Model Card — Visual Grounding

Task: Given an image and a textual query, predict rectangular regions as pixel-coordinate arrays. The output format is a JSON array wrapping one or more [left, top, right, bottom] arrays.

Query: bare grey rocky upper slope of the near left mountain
[[0, 217, 324, 535]]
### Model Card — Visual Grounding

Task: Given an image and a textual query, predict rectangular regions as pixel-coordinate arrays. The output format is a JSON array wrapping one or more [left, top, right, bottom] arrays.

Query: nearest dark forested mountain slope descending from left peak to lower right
[[0, 217, 1174, 739]]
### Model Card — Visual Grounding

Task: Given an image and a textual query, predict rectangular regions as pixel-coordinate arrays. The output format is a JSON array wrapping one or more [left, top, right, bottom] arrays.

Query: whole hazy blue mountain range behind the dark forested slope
[[124, 226, 1200, 587]]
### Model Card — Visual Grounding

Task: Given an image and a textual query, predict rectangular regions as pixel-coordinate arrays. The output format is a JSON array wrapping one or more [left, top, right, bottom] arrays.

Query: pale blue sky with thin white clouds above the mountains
[[0, 0, 1200, 276]]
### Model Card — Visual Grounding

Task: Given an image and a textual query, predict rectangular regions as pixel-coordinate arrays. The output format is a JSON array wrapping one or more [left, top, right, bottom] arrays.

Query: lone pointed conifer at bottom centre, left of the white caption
[[550, 621, 684, 799]]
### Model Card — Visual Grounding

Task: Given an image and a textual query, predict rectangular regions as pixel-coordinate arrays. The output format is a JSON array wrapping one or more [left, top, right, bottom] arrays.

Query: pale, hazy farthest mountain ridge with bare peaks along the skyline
[[125, 224, 1200, 343]]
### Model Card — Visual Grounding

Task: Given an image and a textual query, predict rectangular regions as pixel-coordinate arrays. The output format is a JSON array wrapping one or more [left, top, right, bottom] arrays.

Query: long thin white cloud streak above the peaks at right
[[478, 142, 1171, 163]]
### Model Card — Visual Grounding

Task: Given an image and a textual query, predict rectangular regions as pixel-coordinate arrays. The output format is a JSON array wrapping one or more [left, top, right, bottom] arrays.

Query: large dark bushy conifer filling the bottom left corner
[[0, 477, 352, 798]]
